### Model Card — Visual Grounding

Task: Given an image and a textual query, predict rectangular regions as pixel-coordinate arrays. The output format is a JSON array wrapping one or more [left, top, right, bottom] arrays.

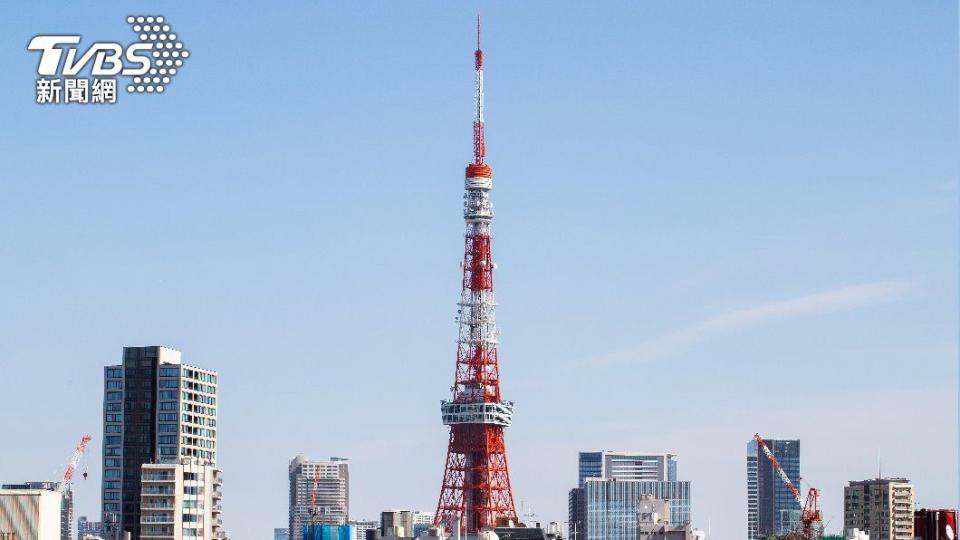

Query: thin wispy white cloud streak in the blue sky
[[594, 281, 912, 364]]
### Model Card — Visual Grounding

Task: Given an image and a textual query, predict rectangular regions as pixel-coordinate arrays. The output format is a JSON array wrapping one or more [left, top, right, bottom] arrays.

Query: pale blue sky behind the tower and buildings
[[0, 0, 958, 540]]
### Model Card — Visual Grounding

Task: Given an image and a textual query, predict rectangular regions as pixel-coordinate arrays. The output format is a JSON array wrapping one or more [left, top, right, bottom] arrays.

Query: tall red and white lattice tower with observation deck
[[435, 17, 517, 535]]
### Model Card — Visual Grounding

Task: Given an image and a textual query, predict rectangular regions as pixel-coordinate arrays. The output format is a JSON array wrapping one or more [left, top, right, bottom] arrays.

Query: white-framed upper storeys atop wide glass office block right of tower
[[577, 450, 677, 486]]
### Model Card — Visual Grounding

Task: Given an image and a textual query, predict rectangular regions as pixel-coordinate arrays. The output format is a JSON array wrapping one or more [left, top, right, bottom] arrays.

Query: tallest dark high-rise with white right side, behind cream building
[[101, 346, 218, 540]]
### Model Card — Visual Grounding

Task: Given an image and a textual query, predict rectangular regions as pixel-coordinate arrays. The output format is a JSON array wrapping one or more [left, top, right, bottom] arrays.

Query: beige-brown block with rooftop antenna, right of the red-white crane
[[843, 478, 914, 540]]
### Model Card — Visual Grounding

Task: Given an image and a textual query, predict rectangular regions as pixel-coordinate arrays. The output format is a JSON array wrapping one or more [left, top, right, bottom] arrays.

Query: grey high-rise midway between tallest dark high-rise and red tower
[[288, 456, 350, 539]]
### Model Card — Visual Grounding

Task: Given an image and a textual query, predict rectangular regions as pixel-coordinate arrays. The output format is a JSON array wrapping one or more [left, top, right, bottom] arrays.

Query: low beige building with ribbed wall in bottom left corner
[[0, 489, 63, 540]]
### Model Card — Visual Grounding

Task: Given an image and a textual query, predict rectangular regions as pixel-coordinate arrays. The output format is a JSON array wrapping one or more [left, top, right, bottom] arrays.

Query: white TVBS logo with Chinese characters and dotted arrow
[[27, 15, 190, 104]]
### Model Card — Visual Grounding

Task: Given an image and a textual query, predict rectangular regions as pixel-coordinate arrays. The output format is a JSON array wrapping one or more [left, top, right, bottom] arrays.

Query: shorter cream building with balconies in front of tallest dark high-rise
[[140, 458, 222, 540]]
